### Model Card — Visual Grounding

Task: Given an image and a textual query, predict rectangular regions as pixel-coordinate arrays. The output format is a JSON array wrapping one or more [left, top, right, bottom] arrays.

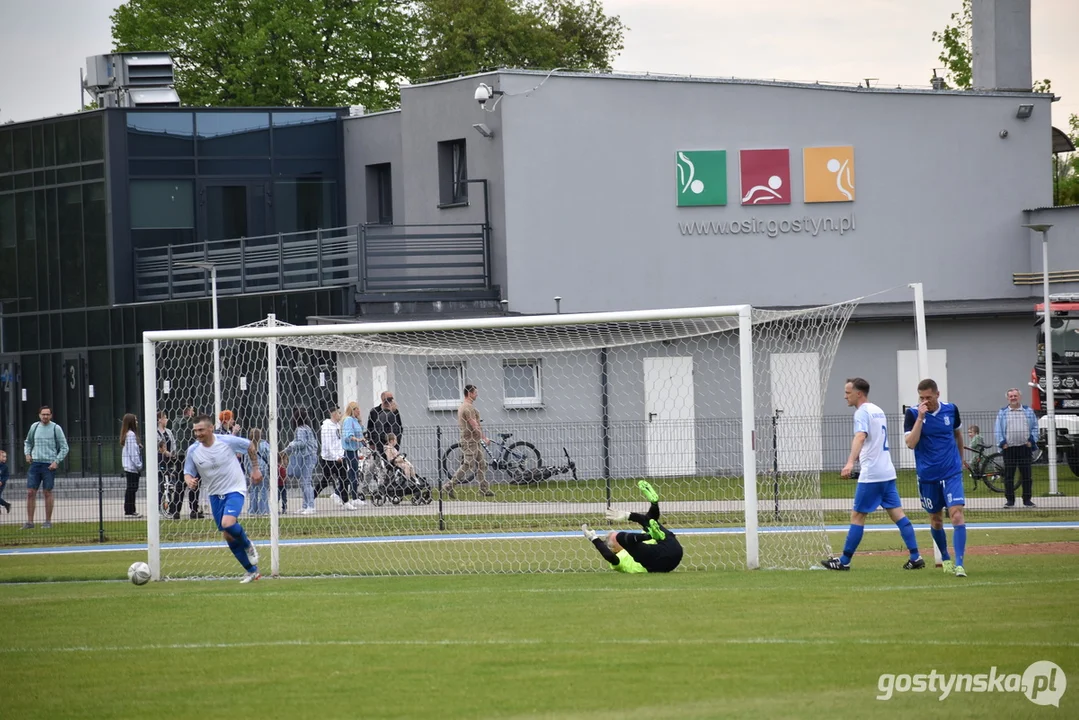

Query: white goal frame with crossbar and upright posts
[[142, 304, 761, 580]]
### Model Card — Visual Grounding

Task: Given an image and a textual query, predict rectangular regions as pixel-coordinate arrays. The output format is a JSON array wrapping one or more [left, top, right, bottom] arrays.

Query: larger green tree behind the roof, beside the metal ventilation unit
[[111, 0, 419, 109]]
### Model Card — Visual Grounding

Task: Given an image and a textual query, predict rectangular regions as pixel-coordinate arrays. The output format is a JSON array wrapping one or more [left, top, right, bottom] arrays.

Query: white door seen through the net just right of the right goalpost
[[772, 353, 823, 472]]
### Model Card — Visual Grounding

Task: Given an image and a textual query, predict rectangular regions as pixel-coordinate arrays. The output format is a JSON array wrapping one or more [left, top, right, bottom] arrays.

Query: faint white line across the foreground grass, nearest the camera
[[0, 638, 1079, 654]]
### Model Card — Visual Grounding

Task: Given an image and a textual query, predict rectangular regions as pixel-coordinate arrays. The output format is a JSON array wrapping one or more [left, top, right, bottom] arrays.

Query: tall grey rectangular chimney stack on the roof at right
[[971, 0, 1033, 93]]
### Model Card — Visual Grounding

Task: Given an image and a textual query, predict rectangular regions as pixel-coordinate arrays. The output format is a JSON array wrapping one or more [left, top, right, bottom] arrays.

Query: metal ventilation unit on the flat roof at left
[[82, 53, 180, 108]]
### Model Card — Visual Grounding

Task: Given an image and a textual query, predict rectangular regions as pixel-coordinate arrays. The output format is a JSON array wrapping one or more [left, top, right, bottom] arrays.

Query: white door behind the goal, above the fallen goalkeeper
[[644, 357, 697, 477]]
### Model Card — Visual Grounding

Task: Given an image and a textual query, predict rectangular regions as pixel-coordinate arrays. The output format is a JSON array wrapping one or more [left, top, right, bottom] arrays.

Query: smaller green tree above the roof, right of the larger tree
[[403, 0, 627, 78]]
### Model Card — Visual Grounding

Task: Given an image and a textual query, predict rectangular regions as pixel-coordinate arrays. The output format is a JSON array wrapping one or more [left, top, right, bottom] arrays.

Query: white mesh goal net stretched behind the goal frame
[[144, 301, 856, 578]]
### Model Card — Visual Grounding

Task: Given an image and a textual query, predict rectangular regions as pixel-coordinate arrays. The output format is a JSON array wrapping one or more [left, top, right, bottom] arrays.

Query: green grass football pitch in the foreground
[[0, 529, 1079, 720]]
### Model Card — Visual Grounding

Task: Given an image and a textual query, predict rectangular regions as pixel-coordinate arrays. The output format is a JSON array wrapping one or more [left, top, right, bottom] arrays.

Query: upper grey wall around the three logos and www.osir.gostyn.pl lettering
[[494, 73, 1052, 313]]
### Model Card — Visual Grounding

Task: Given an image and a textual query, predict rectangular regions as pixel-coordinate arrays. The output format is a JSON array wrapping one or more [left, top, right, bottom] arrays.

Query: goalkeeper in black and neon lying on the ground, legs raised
[[581, 480, 682, 572]]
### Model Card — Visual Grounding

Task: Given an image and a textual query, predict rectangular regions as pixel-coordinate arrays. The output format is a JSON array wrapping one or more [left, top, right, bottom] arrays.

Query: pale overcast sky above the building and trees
[[0, 0, 1079, 128]]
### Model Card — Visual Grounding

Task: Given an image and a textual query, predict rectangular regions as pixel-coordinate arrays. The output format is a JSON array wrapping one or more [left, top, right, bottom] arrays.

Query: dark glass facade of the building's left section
[[0, 108, 351, 464]]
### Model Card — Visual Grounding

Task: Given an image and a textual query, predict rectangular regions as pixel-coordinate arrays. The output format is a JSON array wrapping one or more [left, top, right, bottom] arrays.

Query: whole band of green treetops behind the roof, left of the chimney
[[112, 0, 626, 109]]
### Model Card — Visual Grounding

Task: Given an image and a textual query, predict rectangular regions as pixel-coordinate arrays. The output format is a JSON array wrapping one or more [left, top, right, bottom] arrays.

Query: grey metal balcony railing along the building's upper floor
[[135, 225, 491, 302]]
